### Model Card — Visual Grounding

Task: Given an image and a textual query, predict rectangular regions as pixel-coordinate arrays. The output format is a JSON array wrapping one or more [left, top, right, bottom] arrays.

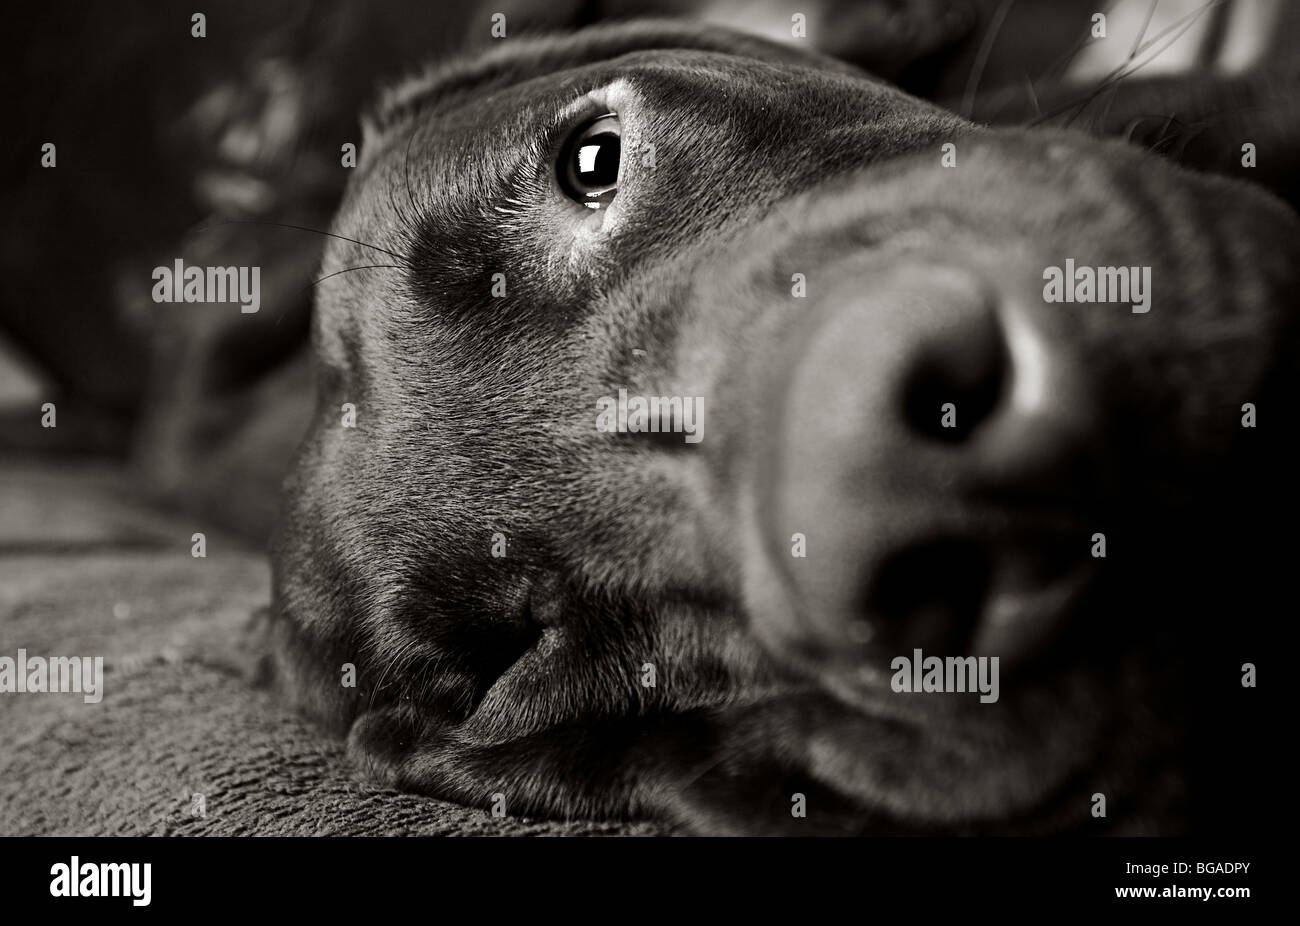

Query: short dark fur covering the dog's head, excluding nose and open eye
[[269, 25, 1300, 832]]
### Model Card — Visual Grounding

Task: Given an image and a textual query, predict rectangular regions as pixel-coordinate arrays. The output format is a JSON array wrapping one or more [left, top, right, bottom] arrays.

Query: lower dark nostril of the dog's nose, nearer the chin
[[858, 540, 992, 655]]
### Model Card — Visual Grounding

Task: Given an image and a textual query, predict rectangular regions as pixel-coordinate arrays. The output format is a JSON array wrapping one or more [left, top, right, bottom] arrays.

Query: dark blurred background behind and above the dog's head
[[0, 0, 1300, 541]]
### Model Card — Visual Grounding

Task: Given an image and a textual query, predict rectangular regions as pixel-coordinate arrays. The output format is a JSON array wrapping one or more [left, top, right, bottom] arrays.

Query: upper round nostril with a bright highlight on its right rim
[[902, 309, 1010, 443]]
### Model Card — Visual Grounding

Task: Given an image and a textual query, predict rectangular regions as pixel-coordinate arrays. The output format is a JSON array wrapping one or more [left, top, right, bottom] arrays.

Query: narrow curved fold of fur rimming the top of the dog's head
[[361, 20, 868, 147]]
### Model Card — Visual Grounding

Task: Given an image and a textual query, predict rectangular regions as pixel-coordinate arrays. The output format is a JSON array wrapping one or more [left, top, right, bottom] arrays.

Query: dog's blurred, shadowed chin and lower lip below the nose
[[807, 647, 1183, 834]]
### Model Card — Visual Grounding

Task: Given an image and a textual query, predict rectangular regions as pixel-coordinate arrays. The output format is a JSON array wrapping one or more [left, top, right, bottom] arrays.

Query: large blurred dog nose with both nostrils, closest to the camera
[[749, 264, 1100, 665]]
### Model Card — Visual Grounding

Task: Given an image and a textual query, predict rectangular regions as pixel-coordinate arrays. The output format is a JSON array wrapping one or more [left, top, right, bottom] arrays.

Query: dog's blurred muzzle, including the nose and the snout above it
[[703, 128, 1295, 688]]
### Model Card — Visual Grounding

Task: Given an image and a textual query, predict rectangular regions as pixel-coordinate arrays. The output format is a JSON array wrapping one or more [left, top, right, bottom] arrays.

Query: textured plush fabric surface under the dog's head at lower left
[[0, 463, 654, 835]]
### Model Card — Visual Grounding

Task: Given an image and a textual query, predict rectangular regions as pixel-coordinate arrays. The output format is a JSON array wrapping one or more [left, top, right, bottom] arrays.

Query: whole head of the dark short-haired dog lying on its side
[[276, 26, 1297, 832]]
